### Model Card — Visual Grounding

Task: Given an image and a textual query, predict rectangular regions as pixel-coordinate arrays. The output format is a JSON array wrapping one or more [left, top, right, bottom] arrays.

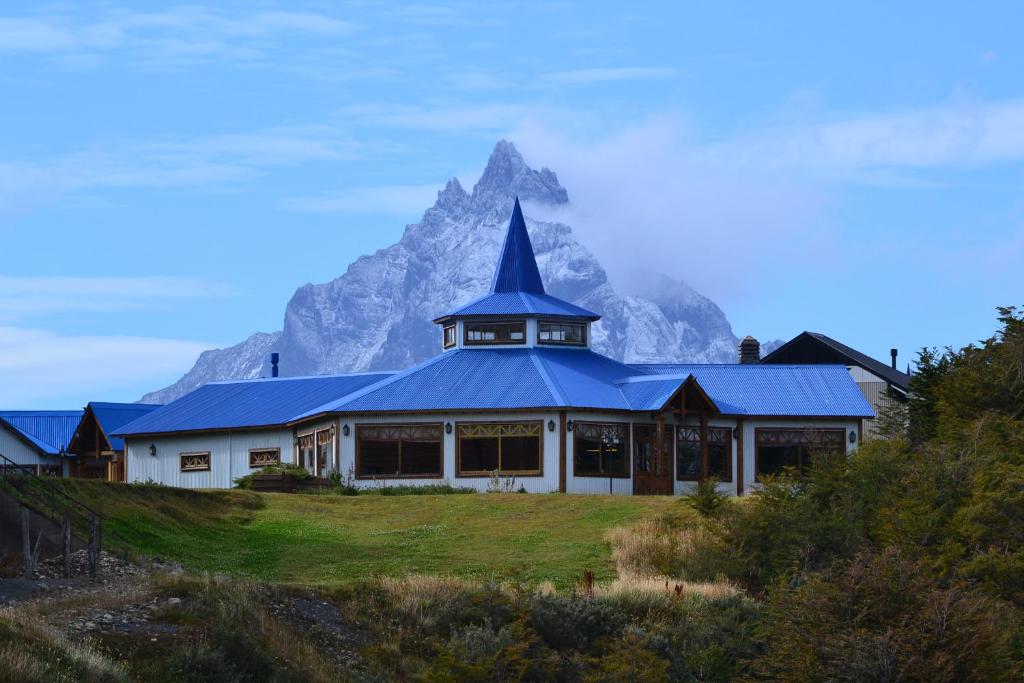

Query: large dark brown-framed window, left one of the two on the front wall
[[355, 424, 442, 477]]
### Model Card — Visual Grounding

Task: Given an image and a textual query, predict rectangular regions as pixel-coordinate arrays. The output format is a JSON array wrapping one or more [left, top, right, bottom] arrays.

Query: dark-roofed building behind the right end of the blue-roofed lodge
[[761, 332, 910, 435]]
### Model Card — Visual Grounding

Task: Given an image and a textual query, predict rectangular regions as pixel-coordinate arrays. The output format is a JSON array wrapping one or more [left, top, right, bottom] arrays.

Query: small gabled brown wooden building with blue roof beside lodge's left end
[[68, 401, 160, 481]]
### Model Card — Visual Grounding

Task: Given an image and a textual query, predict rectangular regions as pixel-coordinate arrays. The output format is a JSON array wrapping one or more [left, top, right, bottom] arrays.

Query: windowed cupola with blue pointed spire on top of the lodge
[[434, 197, 601, 350]]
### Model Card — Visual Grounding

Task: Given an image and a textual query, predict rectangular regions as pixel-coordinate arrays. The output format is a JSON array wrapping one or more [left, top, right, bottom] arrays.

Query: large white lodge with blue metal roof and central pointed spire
[[116, 201, 873, 494]]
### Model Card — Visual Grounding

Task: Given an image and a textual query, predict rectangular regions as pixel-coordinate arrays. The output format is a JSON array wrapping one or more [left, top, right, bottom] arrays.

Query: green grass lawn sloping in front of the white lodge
[[56, 479, 680, 588]]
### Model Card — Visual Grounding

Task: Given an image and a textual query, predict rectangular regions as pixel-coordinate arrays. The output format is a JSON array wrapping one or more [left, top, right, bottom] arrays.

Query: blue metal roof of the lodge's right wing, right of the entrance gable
[[632, 364, 874, 418]]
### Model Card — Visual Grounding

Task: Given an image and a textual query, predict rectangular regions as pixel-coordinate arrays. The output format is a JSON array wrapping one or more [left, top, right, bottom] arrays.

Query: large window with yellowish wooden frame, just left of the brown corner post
[[458, 422, 544, 476]]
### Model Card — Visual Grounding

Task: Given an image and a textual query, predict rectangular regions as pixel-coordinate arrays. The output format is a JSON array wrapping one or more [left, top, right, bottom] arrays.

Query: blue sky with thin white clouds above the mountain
[[0, 2, 1024, 409]]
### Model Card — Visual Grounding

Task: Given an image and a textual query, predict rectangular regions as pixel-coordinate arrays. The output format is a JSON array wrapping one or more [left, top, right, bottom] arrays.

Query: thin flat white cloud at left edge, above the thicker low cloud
[[0, 275, 234, 322]]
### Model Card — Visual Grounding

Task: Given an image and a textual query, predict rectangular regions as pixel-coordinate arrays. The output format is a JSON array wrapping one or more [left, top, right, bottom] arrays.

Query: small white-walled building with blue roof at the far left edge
[[0, 411, 82, 476]]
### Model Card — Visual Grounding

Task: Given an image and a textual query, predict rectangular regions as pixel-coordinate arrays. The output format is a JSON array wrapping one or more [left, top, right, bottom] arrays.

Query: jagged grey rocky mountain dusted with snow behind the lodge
[[142, 140, 737, 402]]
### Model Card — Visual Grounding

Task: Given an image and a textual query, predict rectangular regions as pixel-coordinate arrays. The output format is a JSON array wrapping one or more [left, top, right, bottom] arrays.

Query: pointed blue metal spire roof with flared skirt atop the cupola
[[434, 197, 601, 323]]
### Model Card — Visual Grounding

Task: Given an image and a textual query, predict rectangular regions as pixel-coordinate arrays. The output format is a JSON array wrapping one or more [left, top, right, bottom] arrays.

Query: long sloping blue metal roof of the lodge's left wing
[[114, 373, 390, 437]]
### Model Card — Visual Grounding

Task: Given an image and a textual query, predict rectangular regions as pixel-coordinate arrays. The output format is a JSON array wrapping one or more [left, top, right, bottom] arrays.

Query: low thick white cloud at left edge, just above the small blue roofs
[[0, 327, 214, 409]]
